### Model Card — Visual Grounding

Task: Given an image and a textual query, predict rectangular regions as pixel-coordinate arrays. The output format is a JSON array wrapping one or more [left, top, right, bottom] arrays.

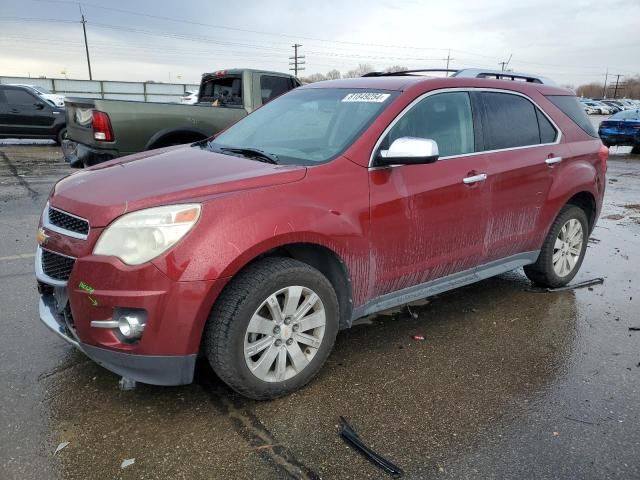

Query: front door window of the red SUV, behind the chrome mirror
[[382, 92, 474, 157]]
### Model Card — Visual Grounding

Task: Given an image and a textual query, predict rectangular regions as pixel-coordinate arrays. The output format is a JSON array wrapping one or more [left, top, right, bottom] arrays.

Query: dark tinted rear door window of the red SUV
[[480, 92, 540, 150]]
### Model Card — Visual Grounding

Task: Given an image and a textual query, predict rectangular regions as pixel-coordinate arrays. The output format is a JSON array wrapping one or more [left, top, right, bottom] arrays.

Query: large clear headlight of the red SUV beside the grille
[[93, 203, 201, 265]]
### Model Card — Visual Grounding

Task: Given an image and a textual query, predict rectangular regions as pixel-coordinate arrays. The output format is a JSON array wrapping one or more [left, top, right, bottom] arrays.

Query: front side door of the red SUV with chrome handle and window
[[369, 91, 490, 297]]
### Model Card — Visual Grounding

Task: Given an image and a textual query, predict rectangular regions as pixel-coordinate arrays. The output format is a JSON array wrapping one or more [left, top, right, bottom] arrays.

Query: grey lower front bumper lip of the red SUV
[[39, 293, 197, 385]]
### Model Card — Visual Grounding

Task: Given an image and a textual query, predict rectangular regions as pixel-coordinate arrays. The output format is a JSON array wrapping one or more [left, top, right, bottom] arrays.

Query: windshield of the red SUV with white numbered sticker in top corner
[[206, 88, 398, 165]]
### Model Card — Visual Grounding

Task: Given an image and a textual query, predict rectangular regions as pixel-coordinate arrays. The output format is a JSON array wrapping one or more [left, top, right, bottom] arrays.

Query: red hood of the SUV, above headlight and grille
[[50, 145, 306, 227]]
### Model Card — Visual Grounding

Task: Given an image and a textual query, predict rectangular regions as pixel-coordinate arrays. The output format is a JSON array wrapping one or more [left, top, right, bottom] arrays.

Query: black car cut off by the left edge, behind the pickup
[[0, 85, 67, 144]]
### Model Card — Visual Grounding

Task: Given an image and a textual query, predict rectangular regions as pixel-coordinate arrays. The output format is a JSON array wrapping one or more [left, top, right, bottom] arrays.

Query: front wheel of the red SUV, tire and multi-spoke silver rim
[[204, 257, 339, 400]]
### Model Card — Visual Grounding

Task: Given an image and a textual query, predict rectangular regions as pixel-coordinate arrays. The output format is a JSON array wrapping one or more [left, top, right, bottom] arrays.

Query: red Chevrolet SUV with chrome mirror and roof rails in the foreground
[[36, 70, 607, 399]]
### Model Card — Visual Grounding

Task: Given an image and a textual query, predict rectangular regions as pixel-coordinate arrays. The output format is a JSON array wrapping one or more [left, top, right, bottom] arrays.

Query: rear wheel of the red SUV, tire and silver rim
[[524, 205, 589, 288]]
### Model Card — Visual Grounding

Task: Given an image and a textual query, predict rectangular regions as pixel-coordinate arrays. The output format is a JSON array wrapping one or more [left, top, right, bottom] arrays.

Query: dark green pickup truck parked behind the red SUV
[[62, 69, 300, 168]]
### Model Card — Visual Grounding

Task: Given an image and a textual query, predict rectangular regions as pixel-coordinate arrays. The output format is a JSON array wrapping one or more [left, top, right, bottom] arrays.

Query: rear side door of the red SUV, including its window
[[473, 91, 571, 262]]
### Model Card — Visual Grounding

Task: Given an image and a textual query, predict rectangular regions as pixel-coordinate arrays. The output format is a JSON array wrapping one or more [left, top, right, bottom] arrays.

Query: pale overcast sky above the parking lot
[[0, 0, 640, 86]]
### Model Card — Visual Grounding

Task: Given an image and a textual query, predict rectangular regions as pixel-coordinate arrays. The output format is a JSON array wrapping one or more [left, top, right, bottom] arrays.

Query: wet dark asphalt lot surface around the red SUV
[[0, 127, 640, 479]]
